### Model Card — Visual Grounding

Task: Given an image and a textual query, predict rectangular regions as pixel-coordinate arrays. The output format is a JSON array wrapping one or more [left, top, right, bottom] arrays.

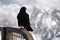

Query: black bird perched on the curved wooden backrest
[[17, 7, 33, 31]]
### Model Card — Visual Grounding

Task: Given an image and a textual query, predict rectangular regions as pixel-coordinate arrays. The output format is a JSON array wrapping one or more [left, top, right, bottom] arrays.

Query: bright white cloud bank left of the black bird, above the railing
[[0, 4, 20, 26]]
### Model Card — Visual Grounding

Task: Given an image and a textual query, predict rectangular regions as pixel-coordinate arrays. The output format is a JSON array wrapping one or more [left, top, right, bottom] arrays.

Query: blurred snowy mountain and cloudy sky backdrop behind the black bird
[[0, 0, 60, 40]]
